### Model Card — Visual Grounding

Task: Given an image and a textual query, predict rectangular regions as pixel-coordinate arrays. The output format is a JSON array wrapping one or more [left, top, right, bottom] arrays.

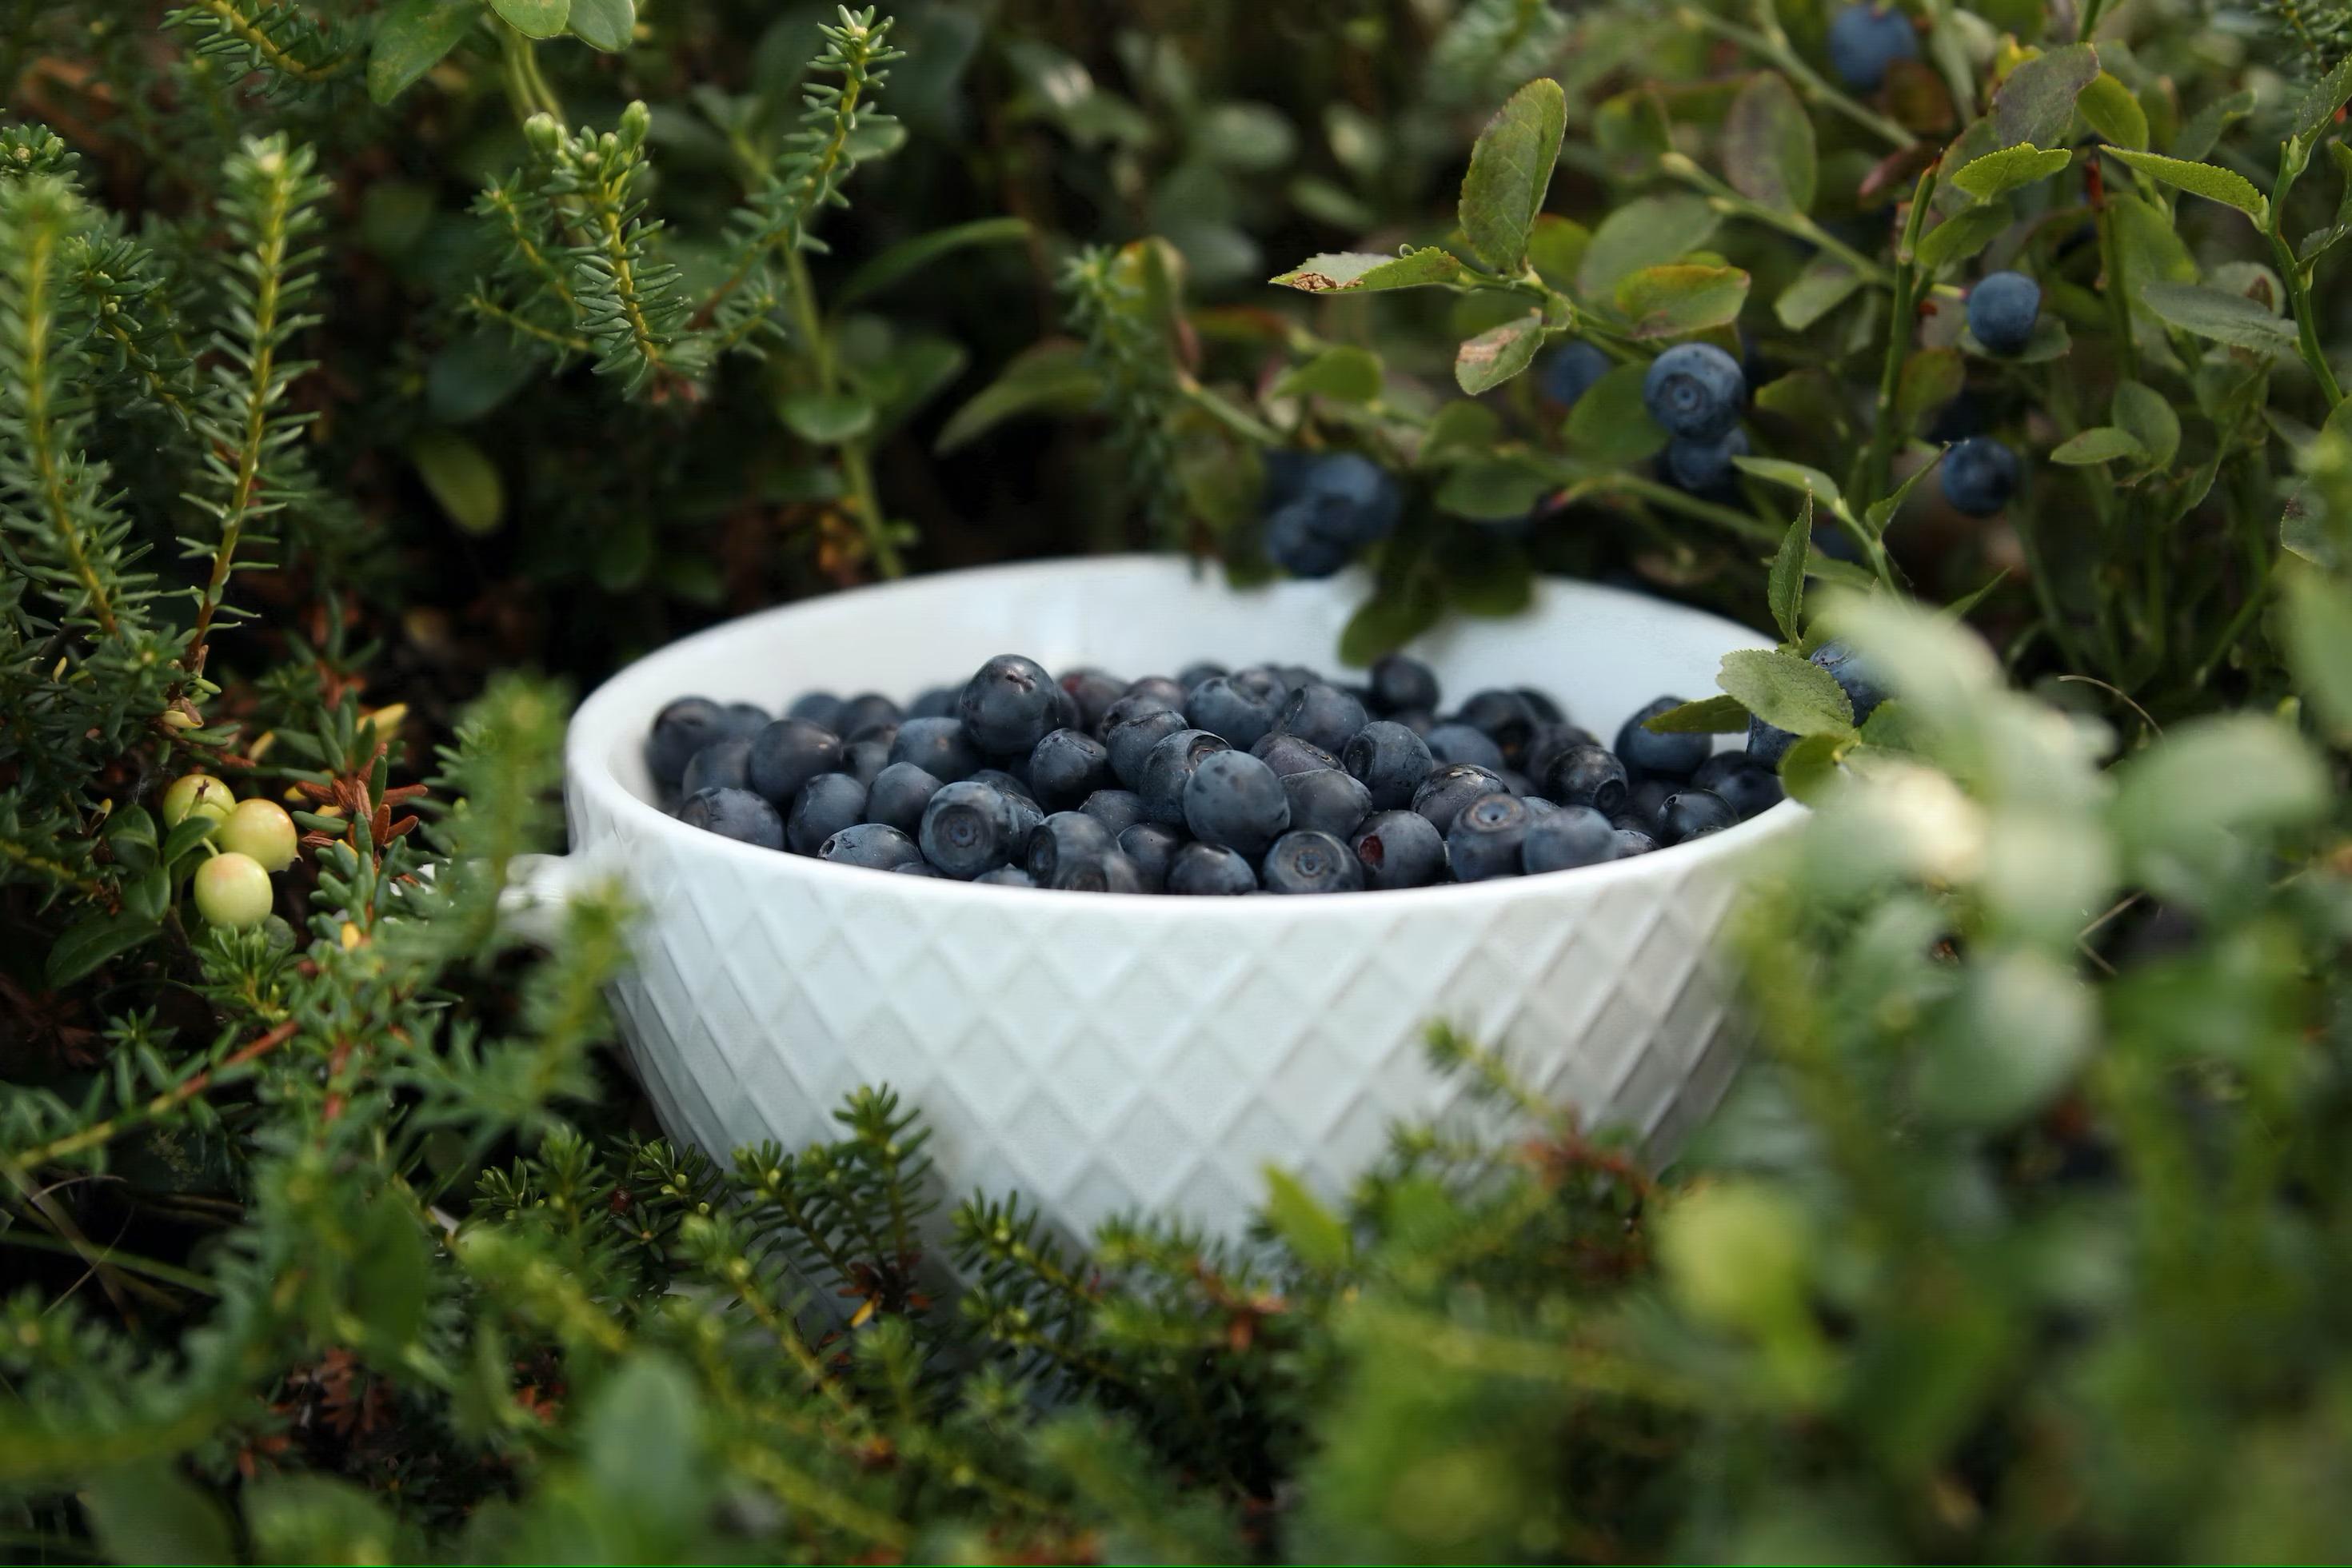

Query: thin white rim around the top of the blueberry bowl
[[565, 553, 1804, 921]]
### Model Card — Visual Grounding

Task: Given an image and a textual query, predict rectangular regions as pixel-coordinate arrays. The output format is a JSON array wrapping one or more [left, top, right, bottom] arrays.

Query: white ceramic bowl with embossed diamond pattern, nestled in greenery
[[522, 557, 1799, 1235]]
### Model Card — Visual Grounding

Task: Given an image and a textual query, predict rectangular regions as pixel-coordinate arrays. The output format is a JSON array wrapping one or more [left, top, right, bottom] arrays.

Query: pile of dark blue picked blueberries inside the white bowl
[[645, 653, 1780, 896]]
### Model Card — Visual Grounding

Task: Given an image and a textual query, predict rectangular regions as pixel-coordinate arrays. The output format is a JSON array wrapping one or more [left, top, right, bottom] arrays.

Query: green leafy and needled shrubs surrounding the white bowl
[[0, 0, 2352, 1561]]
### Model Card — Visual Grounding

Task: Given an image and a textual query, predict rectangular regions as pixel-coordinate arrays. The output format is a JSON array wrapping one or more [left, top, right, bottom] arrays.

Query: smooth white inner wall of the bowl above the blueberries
[[572, 555, 1769, 802]]
